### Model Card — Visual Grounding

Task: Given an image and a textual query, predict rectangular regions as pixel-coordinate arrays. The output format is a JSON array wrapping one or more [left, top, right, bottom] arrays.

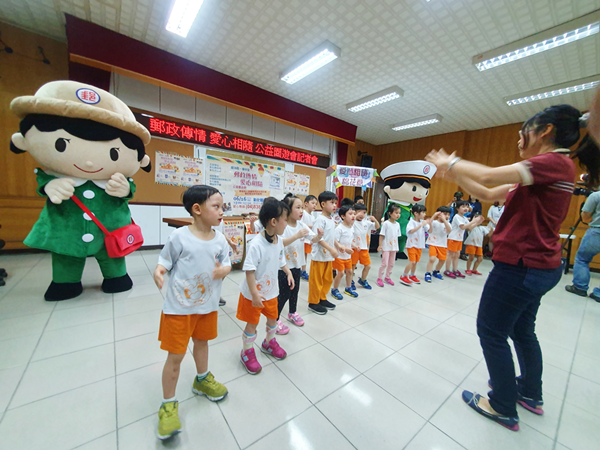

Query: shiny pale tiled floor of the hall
[[0, 251, 600, 450]]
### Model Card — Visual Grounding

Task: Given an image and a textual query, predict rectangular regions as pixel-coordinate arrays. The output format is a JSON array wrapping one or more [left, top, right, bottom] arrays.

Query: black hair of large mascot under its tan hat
[[10, 114, 152, 172]]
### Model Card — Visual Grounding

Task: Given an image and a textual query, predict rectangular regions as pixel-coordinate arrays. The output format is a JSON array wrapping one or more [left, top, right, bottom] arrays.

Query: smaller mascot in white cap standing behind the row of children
[[380, 161, 437, 259]]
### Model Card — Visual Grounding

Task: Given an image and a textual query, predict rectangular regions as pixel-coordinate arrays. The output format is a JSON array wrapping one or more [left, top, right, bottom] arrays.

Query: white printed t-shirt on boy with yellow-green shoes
[[158, 227, 231, 316]]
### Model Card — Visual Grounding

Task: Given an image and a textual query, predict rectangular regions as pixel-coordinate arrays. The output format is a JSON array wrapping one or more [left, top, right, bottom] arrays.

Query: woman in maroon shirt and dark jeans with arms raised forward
[[425, 105, 600, 431]]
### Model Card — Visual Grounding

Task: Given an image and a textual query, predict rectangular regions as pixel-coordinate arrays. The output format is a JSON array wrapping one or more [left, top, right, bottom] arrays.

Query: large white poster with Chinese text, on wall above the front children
[[206, 155, 285, 215]]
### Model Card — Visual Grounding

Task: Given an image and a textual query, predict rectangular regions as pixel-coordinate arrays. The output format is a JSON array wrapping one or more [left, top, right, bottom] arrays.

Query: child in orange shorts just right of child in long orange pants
[[331, 206, 358, 300]]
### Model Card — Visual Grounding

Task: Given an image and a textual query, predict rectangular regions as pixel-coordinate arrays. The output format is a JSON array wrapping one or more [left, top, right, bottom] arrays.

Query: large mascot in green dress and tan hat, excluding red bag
[[10, 81, 150, 301]]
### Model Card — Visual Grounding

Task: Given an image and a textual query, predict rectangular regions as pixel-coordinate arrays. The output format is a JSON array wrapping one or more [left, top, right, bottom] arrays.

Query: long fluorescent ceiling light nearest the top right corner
[[473, 11, 600, 71]]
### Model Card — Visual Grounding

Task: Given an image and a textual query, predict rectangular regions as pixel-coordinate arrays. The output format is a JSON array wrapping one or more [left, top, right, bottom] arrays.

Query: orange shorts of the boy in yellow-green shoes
[[158, 311, 219, 354]]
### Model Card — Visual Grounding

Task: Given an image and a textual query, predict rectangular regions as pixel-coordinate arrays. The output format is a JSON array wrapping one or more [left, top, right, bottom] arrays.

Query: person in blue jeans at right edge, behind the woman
[[565, 188, 600, 302]]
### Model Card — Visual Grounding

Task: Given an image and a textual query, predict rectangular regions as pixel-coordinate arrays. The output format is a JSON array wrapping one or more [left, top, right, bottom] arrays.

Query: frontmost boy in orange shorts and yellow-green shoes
[[154, 186, 231, 439]]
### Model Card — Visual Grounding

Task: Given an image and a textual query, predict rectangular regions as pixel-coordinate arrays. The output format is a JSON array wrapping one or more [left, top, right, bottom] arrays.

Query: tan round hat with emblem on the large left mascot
[[10, 80, 150, 145]]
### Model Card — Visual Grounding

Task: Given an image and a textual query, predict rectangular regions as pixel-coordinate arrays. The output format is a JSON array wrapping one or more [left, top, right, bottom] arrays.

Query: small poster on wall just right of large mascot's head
[[154, 151, 203, 187]]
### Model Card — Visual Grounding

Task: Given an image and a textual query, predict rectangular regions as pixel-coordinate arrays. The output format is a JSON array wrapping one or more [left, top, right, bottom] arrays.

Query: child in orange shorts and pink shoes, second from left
[[236, 197, 295, 375]]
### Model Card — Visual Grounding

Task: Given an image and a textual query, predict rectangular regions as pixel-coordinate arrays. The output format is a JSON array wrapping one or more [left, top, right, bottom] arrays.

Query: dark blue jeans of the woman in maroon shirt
[[477, 261, 562, 417]]
